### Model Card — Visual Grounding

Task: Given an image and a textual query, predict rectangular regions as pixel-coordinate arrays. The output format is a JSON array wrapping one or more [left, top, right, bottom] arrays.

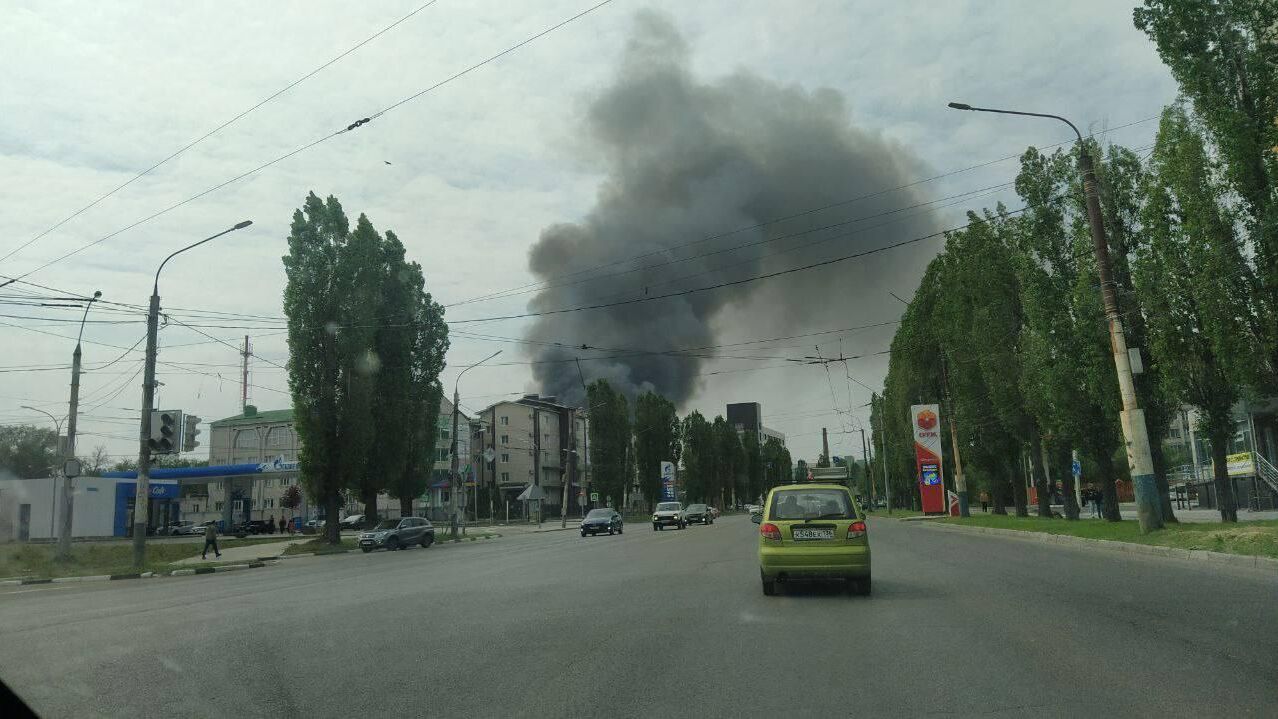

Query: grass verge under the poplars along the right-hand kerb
[[937, 515, 1278, 558]]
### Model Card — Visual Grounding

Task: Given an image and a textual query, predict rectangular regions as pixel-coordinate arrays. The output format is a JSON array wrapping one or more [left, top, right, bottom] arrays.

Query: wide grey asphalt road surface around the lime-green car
[[0, 517, 1278, 719]]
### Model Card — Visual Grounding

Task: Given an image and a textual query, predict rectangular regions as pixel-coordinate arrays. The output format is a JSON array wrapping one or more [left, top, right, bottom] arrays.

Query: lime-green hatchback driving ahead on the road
[[750, 484, 870, 596]]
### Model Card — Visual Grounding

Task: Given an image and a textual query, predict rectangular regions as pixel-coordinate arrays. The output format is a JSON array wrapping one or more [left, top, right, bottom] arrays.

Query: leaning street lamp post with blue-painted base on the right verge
[[950, 102, 1163, 534]]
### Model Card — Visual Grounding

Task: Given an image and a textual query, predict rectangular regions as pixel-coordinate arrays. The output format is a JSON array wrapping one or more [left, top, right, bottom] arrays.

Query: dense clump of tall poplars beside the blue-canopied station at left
[[284, 193, 449, 541]]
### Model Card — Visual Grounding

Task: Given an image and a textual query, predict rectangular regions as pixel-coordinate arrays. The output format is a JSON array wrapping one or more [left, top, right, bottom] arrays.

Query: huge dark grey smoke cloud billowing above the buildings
[[527, 11, 935, 406]]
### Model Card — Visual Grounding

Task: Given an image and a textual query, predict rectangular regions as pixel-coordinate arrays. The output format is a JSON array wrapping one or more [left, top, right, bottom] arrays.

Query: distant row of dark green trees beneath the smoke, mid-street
[[587, 379, 790, 507]]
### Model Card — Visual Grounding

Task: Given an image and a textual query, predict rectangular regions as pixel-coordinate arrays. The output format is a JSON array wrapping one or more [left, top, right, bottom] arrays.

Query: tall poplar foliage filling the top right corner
[[1132, 0, 1278, 382]]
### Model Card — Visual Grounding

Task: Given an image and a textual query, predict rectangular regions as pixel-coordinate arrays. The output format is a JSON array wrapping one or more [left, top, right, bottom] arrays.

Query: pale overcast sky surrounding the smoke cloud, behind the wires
[[0, 0, 1176, 469]]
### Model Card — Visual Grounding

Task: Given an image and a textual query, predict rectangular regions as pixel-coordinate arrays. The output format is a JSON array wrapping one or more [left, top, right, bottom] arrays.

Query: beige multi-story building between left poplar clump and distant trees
[[472, 395, 589, 517]]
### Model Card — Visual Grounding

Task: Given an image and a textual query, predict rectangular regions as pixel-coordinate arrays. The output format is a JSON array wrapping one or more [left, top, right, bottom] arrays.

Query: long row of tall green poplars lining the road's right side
[[874, 0, 1278, 521]]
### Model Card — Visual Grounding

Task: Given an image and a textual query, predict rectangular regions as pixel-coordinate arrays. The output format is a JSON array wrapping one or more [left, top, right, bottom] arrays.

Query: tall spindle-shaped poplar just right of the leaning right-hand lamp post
[[1136, 106, 1255, 522]]
